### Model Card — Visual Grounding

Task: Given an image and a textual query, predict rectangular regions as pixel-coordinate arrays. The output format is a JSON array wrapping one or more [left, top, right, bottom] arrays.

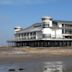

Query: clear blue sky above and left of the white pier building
[[0, 0, 72, 46]]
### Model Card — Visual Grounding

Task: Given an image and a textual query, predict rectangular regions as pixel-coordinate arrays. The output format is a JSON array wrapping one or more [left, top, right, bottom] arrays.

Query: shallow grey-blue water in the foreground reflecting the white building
[[0, 56, 72, 72]]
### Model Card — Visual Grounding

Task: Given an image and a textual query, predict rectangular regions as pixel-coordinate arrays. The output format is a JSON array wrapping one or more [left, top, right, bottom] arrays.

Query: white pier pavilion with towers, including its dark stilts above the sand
[[8, 16, 72, 47]]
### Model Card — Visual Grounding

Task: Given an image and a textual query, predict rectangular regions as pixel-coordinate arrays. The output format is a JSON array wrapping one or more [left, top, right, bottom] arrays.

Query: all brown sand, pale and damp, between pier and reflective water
[[0, 47, 72, 63]]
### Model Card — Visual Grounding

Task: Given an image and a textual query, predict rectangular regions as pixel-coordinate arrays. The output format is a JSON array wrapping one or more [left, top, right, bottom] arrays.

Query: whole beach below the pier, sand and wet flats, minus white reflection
[[0, 47, 72, 72]]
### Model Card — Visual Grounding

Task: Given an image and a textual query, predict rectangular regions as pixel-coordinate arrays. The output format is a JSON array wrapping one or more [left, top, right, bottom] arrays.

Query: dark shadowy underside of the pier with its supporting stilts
[[9, 40, 72, 47]]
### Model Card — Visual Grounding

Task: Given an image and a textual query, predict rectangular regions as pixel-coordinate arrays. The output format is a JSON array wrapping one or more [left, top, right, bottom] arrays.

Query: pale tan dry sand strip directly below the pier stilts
[[0, 47, 72, 57]]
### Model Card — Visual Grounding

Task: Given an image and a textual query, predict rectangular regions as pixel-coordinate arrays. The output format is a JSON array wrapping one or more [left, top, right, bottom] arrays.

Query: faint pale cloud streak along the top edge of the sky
[[0, 0, 48, 5]]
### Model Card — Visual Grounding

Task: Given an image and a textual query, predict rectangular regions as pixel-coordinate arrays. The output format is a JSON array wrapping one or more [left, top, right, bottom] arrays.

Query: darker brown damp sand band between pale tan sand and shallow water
[[0, 54, 59, 64]]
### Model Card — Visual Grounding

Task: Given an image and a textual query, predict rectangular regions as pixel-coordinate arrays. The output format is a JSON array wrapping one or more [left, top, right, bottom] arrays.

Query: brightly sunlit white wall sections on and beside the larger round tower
[[42, 20, 63, 38]]
